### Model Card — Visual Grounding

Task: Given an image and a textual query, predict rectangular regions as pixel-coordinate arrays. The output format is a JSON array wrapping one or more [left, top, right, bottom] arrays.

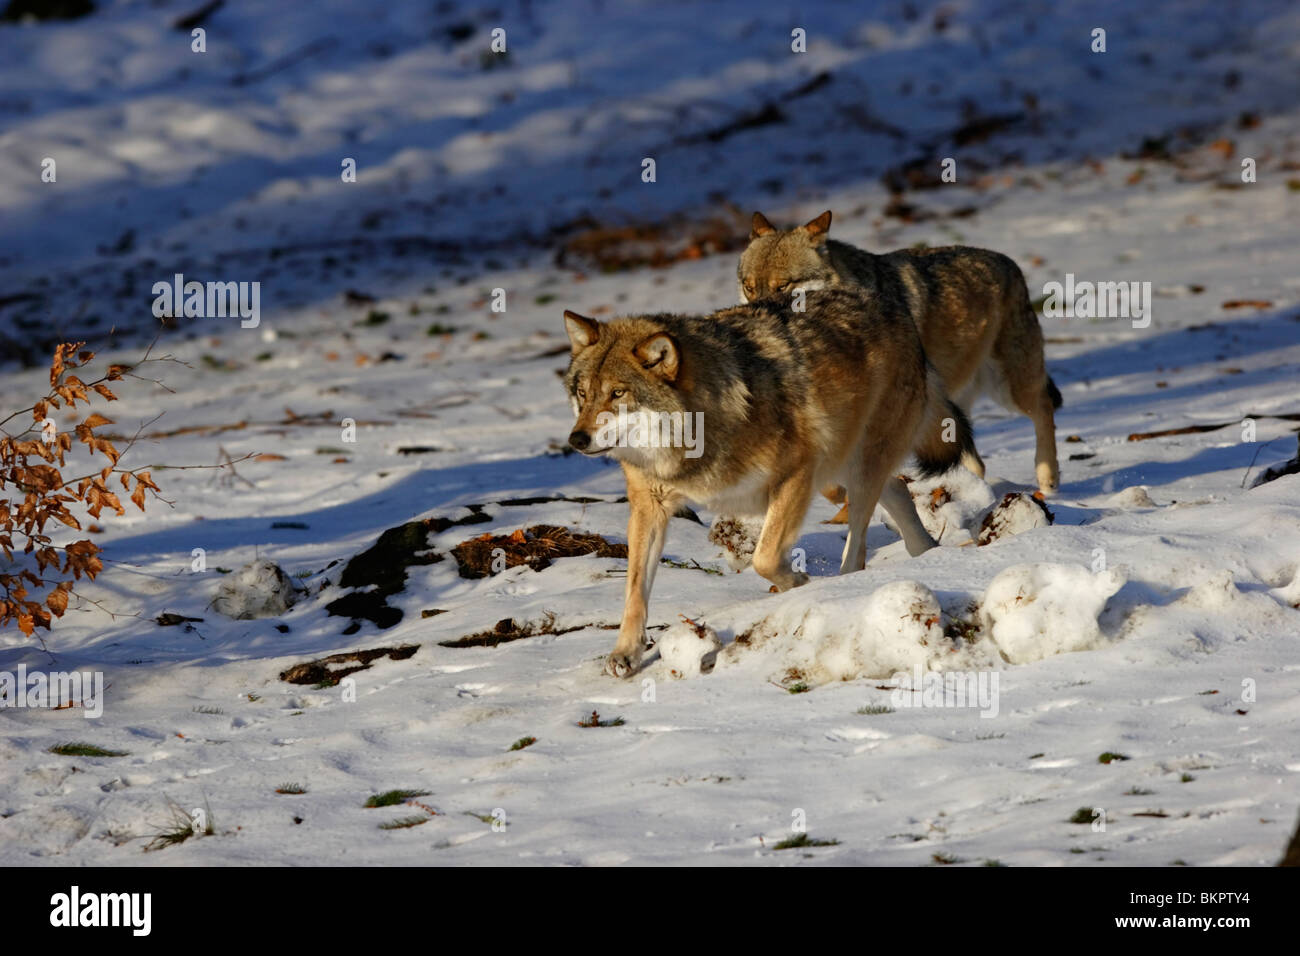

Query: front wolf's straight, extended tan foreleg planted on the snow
[[605, 466, 680, 678]]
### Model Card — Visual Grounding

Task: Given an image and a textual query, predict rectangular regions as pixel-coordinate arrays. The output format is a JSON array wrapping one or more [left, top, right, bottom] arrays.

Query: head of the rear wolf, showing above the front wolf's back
[[736, 209, 839, 302]]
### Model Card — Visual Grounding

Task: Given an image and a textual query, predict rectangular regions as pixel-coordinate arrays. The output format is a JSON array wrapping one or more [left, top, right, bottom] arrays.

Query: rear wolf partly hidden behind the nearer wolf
[[737, 211, 1061, 494]]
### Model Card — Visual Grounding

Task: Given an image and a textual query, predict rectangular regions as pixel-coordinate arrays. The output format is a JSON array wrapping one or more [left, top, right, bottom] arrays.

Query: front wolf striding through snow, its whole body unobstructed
[[564, 290, 974, 676]]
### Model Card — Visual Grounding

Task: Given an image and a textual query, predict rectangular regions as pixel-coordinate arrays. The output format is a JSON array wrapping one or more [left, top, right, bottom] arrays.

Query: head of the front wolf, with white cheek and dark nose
[[564, 312, 698, 473]]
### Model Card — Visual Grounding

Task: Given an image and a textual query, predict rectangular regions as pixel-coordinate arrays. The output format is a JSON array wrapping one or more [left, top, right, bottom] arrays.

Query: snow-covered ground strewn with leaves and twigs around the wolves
[[0, 0, 1300, 866]]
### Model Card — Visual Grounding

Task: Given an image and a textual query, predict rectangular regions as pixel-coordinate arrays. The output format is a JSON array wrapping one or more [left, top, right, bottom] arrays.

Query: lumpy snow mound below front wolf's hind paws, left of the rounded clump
[[718, 580, 998, 684]]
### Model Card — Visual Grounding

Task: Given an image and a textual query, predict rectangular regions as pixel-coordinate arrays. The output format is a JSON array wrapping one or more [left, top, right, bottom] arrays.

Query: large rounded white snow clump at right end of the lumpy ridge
[[979, 564, 1125, 663]]
